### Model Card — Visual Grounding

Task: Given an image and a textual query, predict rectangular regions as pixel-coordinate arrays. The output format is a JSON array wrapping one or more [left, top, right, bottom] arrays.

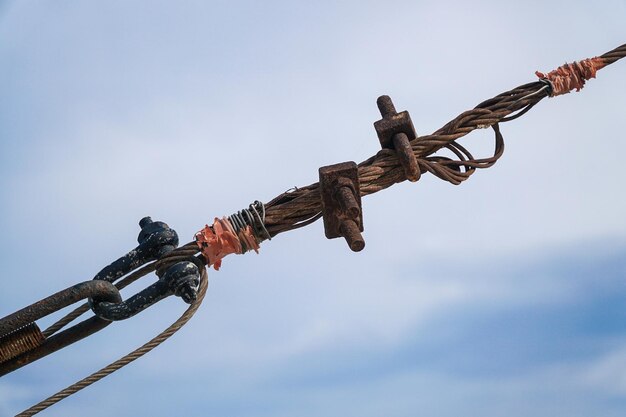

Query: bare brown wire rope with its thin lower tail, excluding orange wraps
[[11, 44, 626, 417]]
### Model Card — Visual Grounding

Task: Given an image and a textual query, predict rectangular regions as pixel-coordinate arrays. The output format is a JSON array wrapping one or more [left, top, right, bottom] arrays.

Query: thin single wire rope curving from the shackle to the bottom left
[[15, 268, 208, 417]]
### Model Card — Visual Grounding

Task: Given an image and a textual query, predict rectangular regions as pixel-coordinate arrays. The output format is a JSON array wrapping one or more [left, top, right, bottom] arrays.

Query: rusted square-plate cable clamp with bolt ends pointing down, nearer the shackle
[[319, 162, 365, 252]]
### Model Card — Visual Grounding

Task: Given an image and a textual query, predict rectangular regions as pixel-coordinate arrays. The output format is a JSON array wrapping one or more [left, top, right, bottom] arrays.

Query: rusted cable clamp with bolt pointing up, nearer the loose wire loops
[[374, 96, 421, 182]]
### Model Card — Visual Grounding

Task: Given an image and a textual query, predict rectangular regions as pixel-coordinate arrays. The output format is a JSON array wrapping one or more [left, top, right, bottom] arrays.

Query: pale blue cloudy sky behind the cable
[[0, 0, 626, 417]]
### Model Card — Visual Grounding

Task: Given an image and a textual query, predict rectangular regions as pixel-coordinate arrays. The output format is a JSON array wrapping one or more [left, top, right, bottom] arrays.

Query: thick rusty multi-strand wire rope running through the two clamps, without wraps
[[258, 44, 626, 236]]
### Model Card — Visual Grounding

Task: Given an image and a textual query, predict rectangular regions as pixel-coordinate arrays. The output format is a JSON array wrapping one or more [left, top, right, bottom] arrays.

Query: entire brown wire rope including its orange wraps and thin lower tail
[[9, 44, 626, 417]]
